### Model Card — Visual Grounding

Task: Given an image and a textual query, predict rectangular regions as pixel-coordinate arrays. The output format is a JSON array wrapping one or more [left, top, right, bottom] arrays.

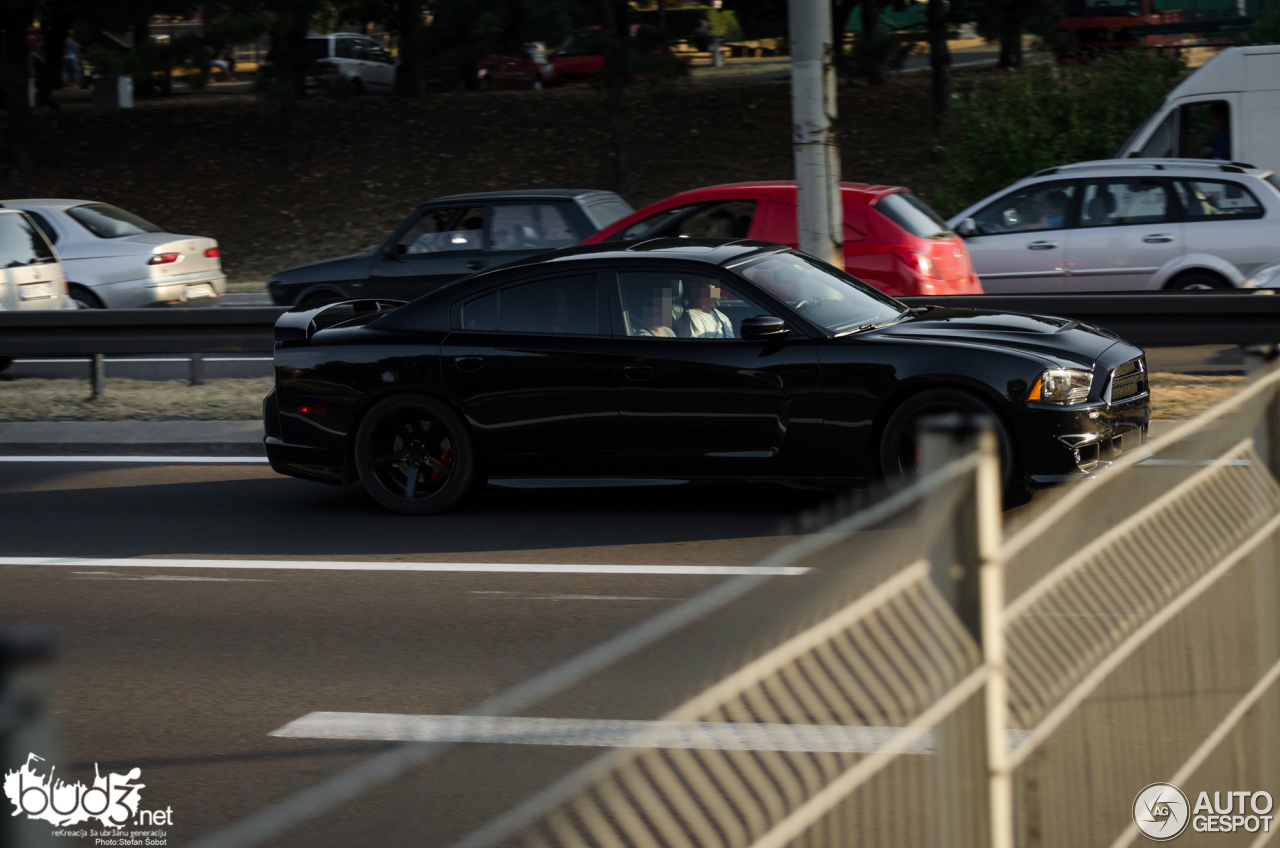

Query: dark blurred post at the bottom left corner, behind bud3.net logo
[[0, 624, 61, 848]]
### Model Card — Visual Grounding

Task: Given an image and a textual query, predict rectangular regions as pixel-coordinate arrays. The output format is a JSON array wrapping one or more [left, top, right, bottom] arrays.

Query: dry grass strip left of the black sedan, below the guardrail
[[0, 377, 273, 421]]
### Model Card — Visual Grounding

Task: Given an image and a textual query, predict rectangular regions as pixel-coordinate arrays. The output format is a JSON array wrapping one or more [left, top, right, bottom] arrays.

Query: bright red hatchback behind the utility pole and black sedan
[[582, 181, 983, 296]]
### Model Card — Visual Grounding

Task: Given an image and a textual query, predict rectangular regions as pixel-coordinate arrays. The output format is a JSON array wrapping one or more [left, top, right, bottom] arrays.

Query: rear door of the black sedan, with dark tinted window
[[440, 272, 618, 477]]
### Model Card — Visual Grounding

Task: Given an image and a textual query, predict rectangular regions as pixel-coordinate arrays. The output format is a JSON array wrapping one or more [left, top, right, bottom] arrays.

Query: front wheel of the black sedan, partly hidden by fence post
[[879, 388, 1016, 497]]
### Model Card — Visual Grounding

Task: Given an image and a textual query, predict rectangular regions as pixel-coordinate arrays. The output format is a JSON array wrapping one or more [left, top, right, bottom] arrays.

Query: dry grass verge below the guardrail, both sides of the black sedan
[[0, 373, 1244, 421]]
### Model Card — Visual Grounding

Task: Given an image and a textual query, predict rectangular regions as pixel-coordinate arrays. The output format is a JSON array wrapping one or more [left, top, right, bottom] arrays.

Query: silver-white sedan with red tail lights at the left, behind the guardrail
[[0, 200, 227, 309]]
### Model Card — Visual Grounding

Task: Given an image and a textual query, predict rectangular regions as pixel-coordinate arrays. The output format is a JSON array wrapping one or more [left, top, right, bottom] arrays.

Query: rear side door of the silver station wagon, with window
[[1064, 177, 1183, 292]]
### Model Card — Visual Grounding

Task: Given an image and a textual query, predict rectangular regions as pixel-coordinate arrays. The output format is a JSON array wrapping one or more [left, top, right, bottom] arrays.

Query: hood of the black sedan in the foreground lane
[[874, 306, 1120, 365]]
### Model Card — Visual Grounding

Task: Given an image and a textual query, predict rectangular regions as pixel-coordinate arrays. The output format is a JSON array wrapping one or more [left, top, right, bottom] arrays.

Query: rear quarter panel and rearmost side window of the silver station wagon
[[1174, 179, 1280, 277]]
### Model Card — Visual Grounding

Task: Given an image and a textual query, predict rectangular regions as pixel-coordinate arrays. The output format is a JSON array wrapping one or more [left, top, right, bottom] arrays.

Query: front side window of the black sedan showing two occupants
[[618, 272, 768, 339]]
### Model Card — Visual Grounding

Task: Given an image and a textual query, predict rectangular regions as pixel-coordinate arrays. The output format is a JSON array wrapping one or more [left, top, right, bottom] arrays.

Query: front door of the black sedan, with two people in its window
[[609, 268, 822, 477]]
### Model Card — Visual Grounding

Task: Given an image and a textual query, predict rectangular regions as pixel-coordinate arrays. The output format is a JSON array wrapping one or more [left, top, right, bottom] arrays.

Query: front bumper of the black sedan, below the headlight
[[1006, 395, 1151, 485]]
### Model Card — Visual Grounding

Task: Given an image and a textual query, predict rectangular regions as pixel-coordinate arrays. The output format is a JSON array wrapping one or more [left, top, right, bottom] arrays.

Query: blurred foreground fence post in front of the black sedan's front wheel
[[919, 414, 1014, 848]]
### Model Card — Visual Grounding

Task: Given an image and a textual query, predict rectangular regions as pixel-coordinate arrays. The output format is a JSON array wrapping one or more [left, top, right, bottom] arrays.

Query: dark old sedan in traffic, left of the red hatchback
[[266, 188, 632, 306]]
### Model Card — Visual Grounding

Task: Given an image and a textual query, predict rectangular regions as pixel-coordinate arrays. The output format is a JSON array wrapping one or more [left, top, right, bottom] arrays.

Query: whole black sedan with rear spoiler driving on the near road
[[264, 238, 1149, 514]]
